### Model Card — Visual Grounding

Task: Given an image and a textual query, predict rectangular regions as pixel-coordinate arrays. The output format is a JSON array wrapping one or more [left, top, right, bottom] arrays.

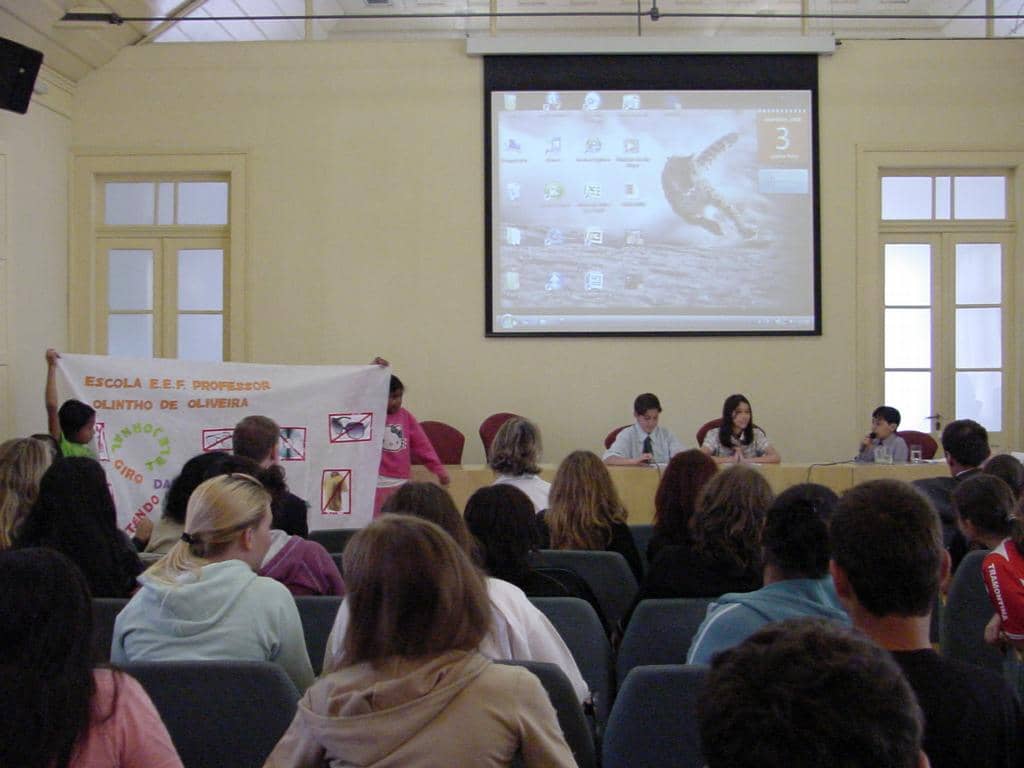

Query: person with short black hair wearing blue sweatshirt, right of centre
[[686, 482, 850, 664]]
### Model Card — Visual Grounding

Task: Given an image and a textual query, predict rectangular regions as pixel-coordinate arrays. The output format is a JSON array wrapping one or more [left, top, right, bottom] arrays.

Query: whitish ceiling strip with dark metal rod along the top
[[0, 0, 1024, 81]]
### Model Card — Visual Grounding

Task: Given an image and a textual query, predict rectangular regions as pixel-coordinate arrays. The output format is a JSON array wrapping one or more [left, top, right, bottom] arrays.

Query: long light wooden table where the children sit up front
[[413, 461, 949, 525]]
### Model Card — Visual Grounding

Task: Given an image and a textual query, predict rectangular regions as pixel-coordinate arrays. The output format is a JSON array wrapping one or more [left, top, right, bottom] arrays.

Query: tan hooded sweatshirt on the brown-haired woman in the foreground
[[264, 650, 575, 768]]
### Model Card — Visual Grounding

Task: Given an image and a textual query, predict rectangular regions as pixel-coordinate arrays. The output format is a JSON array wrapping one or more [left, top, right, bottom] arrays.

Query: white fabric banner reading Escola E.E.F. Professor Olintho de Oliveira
[[57, 354, 390, 534]]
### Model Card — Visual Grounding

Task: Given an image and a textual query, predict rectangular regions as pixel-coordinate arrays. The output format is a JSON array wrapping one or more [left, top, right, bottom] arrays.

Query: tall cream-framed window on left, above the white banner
[[95, 176, 230, 360]]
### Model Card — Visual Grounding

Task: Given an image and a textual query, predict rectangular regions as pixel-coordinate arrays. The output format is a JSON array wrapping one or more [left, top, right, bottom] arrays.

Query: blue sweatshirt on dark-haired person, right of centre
[[686, 577, 850, 664]]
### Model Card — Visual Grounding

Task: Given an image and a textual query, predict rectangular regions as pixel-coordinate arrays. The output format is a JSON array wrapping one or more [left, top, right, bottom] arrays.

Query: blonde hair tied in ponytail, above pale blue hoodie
[[146, 474, 270, 585]]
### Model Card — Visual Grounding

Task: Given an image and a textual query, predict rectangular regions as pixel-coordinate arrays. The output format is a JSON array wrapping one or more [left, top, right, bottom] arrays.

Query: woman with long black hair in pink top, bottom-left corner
[[0, 548, 181, 768]]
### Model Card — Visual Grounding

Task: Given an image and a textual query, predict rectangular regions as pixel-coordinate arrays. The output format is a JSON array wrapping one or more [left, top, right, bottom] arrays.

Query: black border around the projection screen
[[483, 53, 822, 339]]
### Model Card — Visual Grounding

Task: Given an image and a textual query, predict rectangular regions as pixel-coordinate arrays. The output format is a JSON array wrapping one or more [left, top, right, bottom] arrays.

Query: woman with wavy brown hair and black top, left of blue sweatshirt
[[638, 466, 773, 600]]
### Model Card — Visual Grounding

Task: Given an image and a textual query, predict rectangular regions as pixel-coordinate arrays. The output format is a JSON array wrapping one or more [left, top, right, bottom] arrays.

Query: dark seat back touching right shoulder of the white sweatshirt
[[529, 597, 614, 726]]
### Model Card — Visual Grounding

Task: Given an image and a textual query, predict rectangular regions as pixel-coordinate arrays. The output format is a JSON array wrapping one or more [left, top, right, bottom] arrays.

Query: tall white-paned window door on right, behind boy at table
[[880, 170, 1015, 445]]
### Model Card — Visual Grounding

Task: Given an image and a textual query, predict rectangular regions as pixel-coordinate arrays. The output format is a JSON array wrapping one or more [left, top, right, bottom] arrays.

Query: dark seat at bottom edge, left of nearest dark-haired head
[[601, 665, 708, 768]]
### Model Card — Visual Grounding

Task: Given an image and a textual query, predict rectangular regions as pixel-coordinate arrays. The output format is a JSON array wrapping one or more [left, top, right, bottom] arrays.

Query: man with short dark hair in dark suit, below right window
[[913, 419, 989, 570]]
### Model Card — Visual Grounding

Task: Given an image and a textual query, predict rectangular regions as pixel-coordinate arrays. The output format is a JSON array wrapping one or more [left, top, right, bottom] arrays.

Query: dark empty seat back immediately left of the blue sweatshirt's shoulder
[[615, 597, 715, 686]]
